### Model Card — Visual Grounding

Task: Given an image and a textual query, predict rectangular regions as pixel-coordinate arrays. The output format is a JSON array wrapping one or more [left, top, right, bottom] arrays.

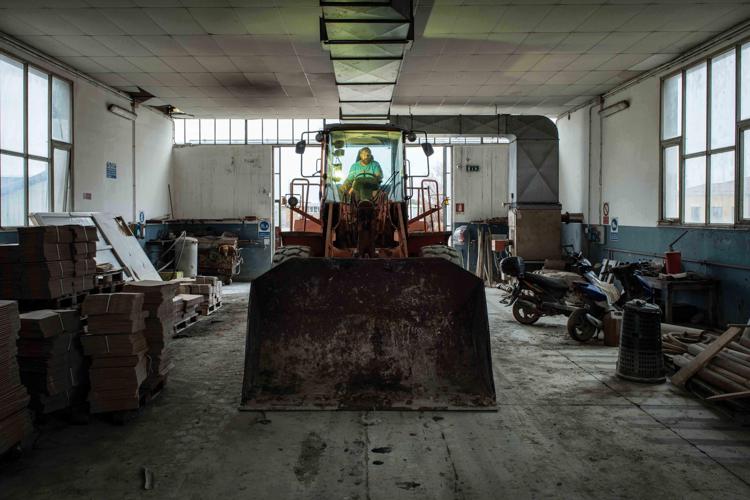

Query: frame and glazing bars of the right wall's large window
[[657, 43, 750, 229]]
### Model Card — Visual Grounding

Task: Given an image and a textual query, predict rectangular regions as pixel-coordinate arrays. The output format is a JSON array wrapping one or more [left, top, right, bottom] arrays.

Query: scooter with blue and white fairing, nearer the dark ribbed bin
[[567, 262, 653, 342]]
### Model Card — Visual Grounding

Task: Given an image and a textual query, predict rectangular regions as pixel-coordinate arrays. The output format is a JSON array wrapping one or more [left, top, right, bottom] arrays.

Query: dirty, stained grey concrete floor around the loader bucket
[[0, 284, 750, 499]]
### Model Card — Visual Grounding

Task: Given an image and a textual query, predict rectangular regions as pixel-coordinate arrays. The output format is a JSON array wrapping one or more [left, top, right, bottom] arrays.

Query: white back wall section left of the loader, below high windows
[[172, 145, 273, 219]]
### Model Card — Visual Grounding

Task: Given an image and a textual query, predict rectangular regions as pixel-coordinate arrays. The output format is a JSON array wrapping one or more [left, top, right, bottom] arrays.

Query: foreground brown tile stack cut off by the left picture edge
[[0, 300, 31, 454]]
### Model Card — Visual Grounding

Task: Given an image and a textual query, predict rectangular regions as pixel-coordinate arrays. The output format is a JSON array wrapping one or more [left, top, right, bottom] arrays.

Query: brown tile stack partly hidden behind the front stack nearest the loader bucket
[[123, 281, 177, 388]]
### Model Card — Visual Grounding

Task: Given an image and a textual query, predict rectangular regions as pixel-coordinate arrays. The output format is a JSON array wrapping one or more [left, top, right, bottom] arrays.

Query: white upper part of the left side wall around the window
[[0, 41, 172, 221]]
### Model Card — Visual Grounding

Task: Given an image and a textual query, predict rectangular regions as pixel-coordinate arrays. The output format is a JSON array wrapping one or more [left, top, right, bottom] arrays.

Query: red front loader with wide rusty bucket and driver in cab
[[242, 124, 495, 410]]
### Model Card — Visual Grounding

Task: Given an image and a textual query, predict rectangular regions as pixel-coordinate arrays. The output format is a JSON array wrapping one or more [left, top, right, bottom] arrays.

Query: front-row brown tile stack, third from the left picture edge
[[81, 293, 148, 413]]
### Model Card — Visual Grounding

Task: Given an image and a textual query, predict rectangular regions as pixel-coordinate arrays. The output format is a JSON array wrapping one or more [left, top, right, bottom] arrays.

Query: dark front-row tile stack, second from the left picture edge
[[18, 309, 86, 413]]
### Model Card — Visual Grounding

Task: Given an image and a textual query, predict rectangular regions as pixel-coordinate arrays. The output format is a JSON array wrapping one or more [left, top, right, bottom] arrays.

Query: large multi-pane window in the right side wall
[[660, 43, 750, 225]]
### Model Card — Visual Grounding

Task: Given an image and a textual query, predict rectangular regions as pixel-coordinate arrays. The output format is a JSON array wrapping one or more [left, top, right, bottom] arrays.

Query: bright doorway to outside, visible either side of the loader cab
[[273, 143, 453, 237]]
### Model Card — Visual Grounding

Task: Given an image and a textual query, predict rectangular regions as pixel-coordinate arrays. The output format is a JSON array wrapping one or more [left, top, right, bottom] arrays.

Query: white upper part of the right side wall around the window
[[557, 29, 747, 227]]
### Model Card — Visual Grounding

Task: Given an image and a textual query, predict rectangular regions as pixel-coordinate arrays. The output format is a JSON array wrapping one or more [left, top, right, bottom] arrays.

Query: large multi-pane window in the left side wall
[[0, 54, 73, 227]]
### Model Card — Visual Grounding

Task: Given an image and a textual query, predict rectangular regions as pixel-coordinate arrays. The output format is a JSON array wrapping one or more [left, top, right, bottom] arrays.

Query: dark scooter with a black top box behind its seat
[[500, 254, 591, 325]]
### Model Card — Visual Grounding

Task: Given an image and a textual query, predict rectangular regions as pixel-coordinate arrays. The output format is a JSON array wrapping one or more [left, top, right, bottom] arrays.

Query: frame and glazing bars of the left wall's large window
[[0, 49, 75, 229]]
